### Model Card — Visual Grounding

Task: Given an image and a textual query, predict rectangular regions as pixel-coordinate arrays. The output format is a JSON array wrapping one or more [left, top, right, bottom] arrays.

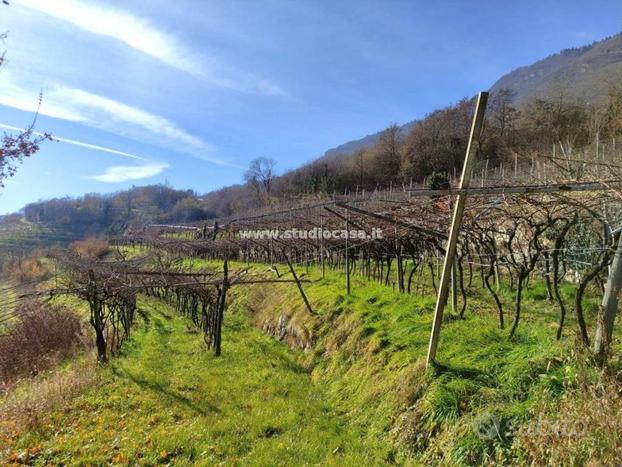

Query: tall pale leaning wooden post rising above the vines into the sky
[[426, 92, 488, 366]]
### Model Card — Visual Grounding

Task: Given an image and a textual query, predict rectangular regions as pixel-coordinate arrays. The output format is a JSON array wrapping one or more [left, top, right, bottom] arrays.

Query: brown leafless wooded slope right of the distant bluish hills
[[203, 86, 622, 215]]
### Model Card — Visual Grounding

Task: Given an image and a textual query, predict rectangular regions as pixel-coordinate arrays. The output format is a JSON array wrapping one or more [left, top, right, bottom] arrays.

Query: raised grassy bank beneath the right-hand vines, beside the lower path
[[194, 260, 596, 465]]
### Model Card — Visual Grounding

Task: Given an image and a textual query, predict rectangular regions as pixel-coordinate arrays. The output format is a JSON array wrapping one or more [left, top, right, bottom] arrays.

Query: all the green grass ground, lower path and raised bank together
[[0, 260, 594, 465]]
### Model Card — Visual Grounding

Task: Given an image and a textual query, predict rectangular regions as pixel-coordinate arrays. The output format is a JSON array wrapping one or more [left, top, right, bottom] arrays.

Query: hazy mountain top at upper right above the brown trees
[[490, 33, 622, 106]]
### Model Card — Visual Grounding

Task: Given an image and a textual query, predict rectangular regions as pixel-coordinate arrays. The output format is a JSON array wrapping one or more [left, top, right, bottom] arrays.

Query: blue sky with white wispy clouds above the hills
[[0, 0, 622, 214]]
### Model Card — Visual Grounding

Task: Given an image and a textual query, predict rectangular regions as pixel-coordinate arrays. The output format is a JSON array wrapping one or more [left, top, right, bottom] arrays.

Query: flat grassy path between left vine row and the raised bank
[[12, 299, 374, 465]]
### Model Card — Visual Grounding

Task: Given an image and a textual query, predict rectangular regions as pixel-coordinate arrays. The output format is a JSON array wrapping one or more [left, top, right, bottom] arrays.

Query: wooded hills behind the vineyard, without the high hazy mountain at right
[[12, 81, 622, 238]]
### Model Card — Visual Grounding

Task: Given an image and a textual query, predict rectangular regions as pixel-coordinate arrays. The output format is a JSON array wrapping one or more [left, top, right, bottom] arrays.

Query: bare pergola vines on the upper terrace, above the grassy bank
[[105, 94, 622, 361]]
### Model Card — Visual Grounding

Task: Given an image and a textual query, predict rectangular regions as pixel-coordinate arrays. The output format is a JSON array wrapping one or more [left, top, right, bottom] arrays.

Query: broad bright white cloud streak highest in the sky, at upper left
[[20, 0, 287, 96]]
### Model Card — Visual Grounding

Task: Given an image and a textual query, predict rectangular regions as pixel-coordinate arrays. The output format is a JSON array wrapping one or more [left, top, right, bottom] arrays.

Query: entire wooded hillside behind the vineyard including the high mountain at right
[[8, 30, 622, 238]]
